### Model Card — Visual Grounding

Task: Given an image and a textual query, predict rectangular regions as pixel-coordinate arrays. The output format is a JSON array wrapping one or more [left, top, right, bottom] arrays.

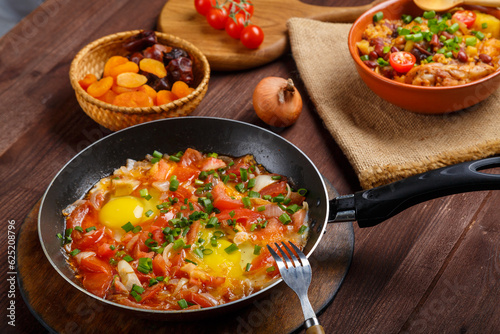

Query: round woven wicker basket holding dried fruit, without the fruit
[[69, 30, 210, 131]]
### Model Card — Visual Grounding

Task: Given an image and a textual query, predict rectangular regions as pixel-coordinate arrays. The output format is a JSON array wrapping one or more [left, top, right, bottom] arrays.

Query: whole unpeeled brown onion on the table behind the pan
[[253, 77, 302, 127]]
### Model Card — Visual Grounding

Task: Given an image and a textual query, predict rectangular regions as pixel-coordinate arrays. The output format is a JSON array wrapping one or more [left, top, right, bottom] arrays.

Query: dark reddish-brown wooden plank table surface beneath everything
[[0, 0, 500, 333]]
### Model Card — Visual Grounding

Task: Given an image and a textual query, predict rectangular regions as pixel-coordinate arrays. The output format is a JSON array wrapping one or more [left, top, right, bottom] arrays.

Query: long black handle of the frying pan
[[330, 157, 500, 227]]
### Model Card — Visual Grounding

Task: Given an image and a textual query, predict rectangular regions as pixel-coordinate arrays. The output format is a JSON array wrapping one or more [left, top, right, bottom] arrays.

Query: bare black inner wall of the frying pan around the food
[[38, 117, 328, 316]]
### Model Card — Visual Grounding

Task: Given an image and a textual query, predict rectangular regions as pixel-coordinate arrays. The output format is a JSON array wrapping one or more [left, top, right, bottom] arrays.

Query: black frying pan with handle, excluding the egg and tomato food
[[38, 117, 500, 320]]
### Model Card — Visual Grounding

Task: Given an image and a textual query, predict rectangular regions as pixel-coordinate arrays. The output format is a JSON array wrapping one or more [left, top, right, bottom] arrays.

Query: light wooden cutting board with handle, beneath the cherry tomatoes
[[157, 0, 383, 71]]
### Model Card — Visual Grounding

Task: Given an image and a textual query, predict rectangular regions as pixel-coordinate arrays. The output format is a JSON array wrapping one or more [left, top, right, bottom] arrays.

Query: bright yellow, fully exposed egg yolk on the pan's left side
[[99, 196, 144, 229]]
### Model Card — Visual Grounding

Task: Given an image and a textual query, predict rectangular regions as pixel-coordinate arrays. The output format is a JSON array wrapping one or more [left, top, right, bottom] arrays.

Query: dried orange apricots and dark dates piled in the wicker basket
[[79, 31, 194, 107]]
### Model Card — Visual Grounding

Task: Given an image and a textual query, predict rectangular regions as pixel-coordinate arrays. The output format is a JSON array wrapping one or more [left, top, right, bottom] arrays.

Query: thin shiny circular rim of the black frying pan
[[37, 116, 330, 315]]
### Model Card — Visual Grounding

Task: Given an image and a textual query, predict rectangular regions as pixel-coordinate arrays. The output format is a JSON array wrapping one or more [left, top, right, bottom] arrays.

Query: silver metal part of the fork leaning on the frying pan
[[267, 241, 325, 334]]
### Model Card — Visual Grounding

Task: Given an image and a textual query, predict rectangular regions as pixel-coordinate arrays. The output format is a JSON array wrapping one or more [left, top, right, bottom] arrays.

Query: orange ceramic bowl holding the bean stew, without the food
[[348, 0, 500, 114]]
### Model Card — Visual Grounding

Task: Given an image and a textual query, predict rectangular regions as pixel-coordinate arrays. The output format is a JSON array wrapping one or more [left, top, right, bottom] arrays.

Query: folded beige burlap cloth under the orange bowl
[[287, 18, 500, 189]]
